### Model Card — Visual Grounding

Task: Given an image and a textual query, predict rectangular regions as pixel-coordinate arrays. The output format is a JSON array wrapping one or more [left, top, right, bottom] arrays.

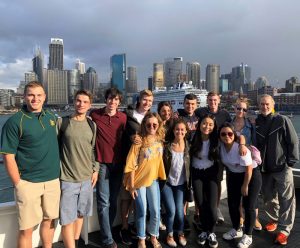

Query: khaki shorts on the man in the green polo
[[15, 179, 60, 230]]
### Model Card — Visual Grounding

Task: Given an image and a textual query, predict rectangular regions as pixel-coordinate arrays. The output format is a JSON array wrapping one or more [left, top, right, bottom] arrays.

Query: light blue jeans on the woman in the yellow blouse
[[135, 180, 160, 239]]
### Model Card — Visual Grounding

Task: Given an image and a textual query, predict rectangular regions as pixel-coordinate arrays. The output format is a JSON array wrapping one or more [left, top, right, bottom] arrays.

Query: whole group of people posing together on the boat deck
[[1, 82, 299, 248]]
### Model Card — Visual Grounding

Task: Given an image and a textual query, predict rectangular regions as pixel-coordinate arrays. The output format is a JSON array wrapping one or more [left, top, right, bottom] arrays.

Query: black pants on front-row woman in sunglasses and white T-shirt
[[226, 168, 262, 235]]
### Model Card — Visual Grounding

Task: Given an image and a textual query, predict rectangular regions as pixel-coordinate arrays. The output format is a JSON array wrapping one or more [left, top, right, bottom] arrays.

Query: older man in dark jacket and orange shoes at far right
[[256, 95, 299, 245]]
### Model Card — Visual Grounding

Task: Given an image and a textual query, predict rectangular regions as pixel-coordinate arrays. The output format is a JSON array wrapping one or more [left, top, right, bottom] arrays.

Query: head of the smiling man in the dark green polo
[[24, 86, 46, 113]]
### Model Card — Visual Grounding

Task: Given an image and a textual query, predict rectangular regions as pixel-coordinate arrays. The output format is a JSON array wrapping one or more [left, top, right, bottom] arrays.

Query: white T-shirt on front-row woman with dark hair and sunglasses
[[220, 142, 252, 173]]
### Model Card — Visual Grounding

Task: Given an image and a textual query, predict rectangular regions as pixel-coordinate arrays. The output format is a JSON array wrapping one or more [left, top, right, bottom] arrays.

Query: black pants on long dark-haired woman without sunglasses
[[192, 165, 219, 233]]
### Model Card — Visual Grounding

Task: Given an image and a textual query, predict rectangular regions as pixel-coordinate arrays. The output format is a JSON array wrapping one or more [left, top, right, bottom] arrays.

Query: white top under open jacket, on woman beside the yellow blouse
[[168, 151, 186, 186]]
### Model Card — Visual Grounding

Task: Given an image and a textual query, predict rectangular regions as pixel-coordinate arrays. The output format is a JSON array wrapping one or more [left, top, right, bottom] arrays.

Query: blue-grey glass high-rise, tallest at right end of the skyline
[[231, 63, 251, 92]]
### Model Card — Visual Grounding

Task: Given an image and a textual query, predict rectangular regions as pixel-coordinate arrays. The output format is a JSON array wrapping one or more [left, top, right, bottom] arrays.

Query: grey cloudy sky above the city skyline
[[0, 0, 300, 89]]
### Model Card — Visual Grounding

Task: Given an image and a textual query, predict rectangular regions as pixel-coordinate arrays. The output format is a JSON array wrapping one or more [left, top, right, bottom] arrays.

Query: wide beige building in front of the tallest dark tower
[[47, 69, 68, 105]]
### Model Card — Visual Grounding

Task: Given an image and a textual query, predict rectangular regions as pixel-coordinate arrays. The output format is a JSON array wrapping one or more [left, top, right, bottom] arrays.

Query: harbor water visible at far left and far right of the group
[[0, 115, 300, 203]]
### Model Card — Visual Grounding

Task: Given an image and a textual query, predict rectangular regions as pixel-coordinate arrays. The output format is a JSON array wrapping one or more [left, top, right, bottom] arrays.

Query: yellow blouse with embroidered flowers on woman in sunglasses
[[124, 142, 166, 190]]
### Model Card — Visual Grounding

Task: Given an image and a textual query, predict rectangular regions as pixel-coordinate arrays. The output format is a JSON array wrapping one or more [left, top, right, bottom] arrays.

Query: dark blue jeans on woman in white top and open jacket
[[161, 183, 186, 234]]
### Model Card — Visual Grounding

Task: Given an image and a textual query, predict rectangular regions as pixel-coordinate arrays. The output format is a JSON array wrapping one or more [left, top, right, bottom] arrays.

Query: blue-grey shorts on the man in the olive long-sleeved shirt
[[59, 179, 93, 225]]
